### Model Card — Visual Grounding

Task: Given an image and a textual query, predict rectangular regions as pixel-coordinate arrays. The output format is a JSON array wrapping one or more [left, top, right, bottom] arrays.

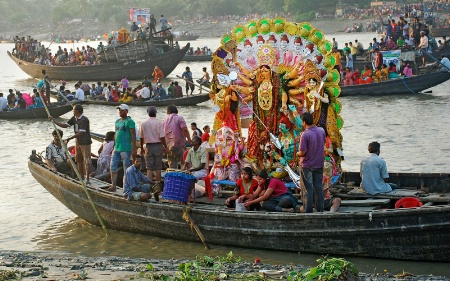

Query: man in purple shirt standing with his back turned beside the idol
[[297, 112, 325, 213]]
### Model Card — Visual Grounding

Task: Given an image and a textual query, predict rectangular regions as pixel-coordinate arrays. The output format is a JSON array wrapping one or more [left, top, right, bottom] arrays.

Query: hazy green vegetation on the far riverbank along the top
[[0, 0, 370, 25]]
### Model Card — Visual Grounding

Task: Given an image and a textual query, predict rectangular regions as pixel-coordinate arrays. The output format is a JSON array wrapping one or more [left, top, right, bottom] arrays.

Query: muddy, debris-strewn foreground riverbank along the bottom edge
[[0, 251, 450, 281]]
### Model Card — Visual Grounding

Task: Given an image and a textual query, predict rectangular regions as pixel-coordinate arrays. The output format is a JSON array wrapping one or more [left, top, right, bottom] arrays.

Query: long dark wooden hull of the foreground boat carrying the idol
[[28, 158, 450, 262]]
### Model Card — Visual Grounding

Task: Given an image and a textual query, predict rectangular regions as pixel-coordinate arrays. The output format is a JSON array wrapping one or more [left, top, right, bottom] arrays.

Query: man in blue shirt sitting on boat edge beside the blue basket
[[123, 156, 152, 201]]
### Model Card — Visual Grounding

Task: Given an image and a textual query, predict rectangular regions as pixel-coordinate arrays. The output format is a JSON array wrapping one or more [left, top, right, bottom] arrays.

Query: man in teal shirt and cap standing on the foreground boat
[[108, 104, 136, 192]]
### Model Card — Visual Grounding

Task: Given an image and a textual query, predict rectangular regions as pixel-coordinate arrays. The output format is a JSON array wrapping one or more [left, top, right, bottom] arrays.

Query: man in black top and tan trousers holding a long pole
[[49, 104, 92, 184]]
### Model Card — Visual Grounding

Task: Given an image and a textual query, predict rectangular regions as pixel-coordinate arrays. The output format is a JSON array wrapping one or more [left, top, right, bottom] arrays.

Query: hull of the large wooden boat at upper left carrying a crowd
[[8, 44, 189, 81]]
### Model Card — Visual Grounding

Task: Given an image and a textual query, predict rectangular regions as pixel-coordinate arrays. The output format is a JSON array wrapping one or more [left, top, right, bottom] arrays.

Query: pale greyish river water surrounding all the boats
[[0, 33, 450, 276]]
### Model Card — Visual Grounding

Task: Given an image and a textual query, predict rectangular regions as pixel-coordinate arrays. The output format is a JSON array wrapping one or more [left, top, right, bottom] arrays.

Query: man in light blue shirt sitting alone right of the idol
[[360, 141, 397, 195]]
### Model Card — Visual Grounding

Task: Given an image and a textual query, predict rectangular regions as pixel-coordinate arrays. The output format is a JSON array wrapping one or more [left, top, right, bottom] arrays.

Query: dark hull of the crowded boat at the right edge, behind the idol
[[340, 71, 450, 97]]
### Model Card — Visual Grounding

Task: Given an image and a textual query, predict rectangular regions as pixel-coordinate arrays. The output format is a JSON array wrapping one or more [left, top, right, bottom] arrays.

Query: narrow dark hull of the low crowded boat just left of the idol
[[82, 94, 210, 106]]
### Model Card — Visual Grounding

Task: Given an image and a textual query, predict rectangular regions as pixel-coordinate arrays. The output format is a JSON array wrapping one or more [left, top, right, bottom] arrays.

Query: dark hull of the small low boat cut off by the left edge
[[0, 102, 76, 119]]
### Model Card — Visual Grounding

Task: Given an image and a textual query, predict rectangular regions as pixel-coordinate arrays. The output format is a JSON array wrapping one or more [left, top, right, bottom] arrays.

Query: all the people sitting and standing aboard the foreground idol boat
[[40, 97, 396, 213]]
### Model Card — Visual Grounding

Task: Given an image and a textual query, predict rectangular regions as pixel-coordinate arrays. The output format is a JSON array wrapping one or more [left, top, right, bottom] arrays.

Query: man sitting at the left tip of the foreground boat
[[45, 130, 72, 176]]
